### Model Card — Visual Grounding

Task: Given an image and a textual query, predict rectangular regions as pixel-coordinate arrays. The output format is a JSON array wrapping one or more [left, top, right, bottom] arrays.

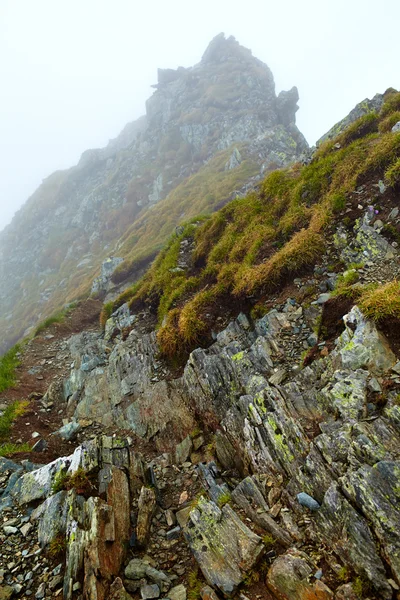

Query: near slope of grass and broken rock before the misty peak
[[0, 40, 400, 600]]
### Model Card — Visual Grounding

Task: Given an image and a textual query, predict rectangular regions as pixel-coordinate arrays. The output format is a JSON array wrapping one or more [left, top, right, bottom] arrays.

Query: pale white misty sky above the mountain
[[0, 0, 400, 229]]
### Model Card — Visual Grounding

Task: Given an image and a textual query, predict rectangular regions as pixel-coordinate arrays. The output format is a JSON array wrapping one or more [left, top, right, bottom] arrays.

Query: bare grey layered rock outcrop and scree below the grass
[[0, 180, 400, 600]]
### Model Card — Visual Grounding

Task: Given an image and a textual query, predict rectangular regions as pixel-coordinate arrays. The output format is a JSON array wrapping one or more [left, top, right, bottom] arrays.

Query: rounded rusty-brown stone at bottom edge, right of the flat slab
[[267, 549, 334, 600]]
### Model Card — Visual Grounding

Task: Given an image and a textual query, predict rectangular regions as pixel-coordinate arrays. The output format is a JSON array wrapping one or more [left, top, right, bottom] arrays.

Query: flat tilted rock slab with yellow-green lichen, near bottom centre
[[185, 497, 264, 596]]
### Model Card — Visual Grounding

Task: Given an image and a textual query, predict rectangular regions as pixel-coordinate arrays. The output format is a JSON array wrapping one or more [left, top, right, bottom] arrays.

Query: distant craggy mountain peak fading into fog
[[0, 34, 308, 351]]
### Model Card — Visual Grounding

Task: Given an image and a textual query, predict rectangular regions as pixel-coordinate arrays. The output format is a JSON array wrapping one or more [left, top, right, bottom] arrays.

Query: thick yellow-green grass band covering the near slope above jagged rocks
[[103, 91, 400, 358]]
